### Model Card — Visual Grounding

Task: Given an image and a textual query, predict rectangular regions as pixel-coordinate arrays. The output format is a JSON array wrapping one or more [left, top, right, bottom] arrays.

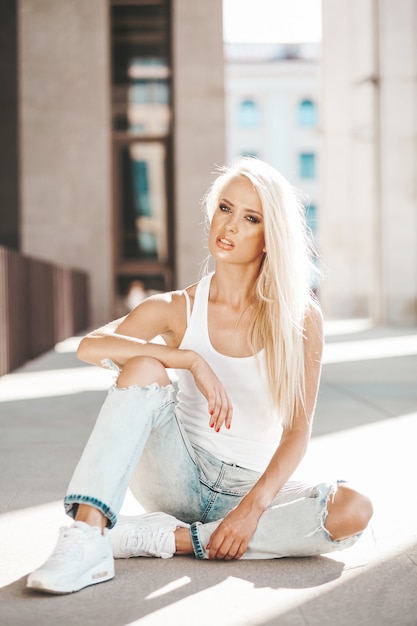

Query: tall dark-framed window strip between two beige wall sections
[[110, 0, 174, 314]]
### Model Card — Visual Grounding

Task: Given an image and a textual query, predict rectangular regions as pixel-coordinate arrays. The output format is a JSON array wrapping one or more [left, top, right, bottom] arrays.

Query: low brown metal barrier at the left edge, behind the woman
[[0, 246, 89, 375]]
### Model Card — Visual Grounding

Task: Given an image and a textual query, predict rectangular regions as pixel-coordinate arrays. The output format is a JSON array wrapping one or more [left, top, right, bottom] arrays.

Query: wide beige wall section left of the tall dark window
[[19, 0, 113, 324]]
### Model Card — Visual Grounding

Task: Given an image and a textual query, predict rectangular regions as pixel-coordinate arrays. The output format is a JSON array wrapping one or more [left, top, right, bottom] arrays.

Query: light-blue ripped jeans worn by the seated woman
[[64, 383, 357, 559]]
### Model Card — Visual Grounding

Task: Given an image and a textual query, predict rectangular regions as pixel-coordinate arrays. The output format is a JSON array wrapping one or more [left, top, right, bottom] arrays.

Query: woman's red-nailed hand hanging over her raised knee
[[189, 353, 233, 433]]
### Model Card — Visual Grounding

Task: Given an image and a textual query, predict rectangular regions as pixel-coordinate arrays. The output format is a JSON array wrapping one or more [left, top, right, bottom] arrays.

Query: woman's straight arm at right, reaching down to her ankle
[[209, 300, 323, 559]]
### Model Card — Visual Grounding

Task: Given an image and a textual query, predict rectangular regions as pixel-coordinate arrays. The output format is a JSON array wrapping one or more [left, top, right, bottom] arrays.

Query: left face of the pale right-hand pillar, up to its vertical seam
[[319, 0, 376, 317]]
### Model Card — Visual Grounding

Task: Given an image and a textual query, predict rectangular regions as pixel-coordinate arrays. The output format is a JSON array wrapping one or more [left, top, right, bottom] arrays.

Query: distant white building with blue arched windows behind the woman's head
[[225, 44, 320, 243]]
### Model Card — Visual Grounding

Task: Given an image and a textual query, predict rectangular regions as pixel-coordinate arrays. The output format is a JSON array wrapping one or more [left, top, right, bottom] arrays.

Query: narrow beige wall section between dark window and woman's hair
[[173, 0, 225, 287]]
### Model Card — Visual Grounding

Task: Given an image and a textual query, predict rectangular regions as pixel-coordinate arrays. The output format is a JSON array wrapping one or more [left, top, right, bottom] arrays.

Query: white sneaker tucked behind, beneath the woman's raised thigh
[[109, 513, 190, 559]]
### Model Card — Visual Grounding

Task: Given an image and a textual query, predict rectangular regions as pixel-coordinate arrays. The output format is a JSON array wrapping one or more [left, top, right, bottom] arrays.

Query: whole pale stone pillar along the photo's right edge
[[318, 0, 417, 324]]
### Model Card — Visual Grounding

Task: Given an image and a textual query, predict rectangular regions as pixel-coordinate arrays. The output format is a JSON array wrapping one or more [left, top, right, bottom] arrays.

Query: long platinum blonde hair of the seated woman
[[205, 157, 314, 426]]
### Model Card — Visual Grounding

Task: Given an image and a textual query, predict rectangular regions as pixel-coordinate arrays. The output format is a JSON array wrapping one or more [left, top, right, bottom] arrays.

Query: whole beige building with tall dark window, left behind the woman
[[0, 0, 225, 325]]
